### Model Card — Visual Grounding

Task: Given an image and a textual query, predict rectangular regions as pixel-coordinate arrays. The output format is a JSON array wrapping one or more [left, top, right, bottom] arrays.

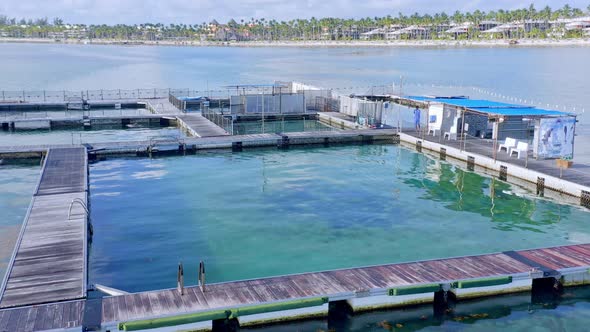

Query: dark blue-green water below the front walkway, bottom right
[[244, 287, 590, 332]]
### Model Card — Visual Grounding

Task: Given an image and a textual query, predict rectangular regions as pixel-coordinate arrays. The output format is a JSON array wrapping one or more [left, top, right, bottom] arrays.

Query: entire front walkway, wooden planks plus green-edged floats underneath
[[102, 244, 590, 330]]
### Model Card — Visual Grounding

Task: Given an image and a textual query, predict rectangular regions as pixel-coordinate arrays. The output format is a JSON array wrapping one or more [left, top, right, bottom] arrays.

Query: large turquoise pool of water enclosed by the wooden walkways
[[90, 145, 590, 291]]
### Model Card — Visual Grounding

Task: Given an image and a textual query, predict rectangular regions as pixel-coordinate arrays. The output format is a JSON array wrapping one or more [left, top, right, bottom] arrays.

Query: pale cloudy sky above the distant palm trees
[[0, 0, 590, 24]]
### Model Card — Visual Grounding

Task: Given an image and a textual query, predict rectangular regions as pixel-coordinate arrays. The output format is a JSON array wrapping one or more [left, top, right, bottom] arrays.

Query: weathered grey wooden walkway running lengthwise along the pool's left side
[[0, 147, 88, 308]]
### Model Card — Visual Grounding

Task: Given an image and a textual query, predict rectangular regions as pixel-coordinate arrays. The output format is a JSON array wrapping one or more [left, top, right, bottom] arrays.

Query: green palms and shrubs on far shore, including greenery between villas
[[0, 4, 590, 41]]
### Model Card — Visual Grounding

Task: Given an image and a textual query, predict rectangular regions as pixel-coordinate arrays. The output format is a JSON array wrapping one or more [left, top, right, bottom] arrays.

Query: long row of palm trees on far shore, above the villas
[[0, 4, 590, 41]]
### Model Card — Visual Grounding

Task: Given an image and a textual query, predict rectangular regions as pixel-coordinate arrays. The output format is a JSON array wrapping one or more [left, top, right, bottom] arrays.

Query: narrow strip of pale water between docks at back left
[[0, 127, 183, 146]]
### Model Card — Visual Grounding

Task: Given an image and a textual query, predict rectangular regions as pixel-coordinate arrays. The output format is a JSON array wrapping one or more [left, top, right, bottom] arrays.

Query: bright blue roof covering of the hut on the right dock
[[406, 96, 572, 117]]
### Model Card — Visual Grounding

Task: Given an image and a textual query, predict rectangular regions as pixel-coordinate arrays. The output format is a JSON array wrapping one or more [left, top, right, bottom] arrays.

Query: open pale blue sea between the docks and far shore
[[0, 43, 590, 158]]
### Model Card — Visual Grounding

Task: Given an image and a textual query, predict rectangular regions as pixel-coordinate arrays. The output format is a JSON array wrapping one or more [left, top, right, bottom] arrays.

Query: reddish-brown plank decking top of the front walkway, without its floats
[[102, 244, 590, 324]]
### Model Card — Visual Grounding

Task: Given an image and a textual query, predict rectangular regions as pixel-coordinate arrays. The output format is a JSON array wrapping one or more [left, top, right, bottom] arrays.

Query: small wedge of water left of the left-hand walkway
[[0, 160, 41, 282]]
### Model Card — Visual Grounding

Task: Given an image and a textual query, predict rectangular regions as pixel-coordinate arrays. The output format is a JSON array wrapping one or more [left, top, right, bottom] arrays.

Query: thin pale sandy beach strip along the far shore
[[0, 37, 590, 48]]
